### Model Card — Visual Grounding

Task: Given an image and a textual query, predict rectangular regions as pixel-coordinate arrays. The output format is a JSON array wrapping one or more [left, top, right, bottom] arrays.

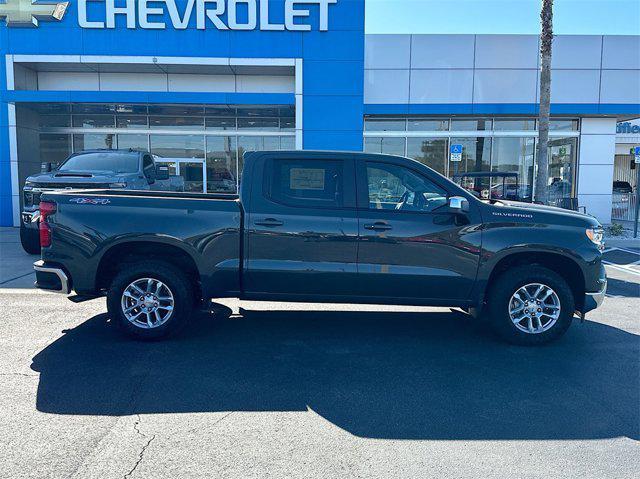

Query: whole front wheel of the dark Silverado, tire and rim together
[[488, 265, 575, 346]]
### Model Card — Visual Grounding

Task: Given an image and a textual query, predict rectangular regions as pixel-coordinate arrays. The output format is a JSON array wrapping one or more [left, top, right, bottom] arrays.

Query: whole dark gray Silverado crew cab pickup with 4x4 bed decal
[[35, 151, 607, 344]]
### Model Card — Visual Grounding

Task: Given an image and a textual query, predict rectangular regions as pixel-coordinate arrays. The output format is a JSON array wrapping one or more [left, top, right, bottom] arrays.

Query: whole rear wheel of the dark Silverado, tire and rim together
[[107, 261, 194, 339]]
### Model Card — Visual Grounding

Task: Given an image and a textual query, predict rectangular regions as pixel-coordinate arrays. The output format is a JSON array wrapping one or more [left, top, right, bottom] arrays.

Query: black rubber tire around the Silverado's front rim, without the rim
[[487, 265, 575, 346]]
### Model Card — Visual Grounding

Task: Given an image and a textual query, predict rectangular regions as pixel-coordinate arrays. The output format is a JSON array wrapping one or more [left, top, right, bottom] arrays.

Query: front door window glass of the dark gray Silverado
[[367, 163, 447, 211]]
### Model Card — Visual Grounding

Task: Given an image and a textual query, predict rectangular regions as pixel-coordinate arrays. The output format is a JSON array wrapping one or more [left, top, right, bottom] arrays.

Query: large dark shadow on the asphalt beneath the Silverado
[[32, 311, 640, 440]]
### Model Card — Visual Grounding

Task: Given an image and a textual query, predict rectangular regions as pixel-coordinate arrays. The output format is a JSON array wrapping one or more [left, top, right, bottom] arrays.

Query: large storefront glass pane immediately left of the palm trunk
[[491, 137, 535, 201]]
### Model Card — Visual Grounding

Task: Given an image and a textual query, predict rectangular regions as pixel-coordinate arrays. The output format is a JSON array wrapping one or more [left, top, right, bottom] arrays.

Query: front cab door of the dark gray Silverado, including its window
[[357, 157, 481, 304]]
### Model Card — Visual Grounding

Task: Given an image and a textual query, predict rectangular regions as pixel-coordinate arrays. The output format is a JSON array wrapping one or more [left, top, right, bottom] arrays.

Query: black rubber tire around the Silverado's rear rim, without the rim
[[107, 260, 194, 340]]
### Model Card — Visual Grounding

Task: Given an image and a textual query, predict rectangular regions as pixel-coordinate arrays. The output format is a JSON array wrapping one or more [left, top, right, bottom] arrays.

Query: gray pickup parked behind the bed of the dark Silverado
[[20, 150, 184, 254]]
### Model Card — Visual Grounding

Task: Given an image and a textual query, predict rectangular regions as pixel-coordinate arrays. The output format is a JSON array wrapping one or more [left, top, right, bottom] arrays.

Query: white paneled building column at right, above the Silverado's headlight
[[578, 118, 616, 224]]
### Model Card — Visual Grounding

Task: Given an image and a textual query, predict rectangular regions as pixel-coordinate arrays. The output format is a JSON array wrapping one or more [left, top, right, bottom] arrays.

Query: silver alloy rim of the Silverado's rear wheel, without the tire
[[120, 278, 174, 329]]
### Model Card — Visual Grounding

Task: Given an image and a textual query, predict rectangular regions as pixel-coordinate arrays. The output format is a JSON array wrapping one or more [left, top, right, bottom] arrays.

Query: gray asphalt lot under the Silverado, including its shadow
[[0, 229, 640, 479]]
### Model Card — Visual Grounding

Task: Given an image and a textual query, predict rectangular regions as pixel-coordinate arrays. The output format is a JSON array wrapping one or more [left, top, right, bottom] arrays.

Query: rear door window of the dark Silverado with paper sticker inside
[[270, 160, 344, 208]]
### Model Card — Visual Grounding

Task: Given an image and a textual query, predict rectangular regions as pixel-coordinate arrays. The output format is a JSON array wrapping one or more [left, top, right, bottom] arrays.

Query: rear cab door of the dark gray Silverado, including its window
[[243, 152, 358, 299]]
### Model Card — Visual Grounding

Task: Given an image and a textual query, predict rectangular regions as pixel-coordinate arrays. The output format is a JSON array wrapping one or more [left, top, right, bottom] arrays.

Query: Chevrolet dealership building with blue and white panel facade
[[0, 0, 640, 226]]
